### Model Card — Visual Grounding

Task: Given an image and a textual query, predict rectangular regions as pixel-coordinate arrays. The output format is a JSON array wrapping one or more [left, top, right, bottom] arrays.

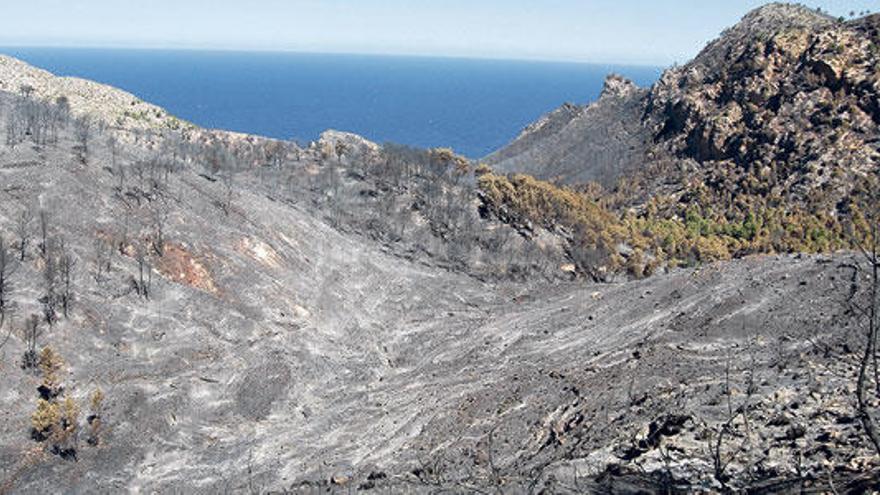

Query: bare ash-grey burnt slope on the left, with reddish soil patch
[[0, 90, 501, 493]]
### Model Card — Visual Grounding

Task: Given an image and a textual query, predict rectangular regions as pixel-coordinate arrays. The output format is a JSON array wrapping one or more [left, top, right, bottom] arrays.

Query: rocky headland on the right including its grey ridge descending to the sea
[[488, 4, 880, 199]]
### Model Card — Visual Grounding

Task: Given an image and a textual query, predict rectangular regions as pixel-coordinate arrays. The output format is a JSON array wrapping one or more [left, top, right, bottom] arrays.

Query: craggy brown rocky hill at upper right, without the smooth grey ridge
[[645, 5, 880, 206]]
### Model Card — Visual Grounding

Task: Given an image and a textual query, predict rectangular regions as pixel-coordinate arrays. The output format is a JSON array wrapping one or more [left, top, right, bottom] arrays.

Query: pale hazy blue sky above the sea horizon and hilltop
[[0, 0, 880, 65]]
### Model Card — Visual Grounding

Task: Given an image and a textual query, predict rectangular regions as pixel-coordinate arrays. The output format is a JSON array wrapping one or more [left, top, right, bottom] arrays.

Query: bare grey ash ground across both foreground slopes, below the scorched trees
[[0, 90, 877, 493]]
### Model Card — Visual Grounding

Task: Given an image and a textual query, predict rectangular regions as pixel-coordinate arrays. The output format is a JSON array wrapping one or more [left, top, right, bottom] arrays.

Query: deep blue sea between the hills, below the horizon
[[0, 48, 661, 158]]
